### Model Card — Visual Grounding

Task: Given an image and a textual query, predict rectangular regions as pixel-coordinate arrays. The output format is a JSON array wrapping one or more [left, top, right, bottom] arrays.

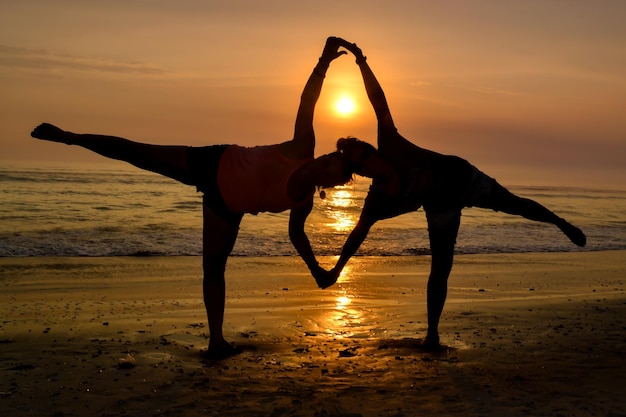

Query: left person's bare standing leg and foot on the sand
[[202, 200, 243, 359]]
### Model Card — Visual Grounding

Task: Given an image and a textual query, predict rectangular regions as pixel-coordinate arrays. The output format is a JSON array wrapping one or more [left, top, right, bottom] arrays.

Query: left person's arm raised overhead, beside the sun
[[283, 36, 347, 158]]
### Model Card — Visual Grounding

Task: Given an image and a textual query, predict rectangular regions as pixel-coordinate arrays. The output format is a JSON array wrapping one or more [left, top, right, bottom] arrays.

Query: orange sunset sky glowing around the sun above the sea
[[0, 0, 626, 188]]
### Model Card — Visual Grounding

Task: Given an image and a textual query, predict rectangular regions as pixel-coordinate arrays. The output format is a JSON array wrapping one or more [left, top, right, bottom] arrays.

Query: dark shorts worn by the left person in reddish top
[[187, 145, 243, 223]]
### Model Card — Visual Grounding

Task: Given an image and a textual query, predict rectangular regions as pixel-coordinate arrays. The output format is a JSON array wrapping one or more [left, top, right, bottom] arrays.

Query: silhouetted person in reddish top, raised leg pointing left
[[31, 37, 352, 358]]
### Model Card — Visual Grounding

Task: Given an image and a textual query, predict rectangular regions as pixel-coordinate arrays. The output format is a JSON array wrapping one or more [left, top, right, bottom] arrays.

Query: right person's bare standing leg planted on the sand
[[423, 209, 461, 350]]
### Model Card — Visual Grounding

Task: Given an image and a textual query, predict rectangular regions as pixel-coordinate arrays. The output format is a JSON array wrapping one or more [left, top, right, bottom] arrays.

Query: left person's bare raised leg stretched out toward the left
[[31, 123, 192, 184]]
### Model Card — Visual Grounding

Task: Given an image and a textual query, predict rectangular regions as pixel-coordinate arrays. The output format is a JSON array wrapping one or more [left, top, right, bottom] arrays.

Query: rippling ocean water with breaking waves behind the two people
[[0, 164, 626, 257]]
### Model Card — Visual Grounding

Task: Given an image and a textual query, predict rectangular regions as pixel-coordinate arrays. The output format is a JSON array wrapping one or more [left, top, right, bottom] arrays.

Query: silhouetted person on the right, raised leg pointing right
[[318, 39, 586, 349]]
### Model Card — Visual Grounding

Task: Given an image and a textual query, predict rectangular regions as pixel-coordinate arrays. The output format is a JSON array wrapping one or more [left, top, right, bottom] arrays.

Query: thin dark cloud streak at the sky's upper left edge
[[0, 45, 169, 76]]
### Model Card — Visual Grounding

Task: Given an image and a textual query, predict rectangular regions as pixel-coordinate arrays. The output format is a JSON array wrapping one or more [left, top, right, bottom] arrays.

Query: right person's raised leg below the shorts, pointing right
[[475, 181, 587, 246]]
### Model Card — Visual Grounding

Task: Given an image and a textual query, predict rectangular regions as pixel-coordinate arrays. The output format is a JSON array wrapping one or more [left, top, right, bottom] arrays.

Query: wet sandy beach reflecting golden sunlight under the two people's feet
[[0, 251, 626, 417]]
